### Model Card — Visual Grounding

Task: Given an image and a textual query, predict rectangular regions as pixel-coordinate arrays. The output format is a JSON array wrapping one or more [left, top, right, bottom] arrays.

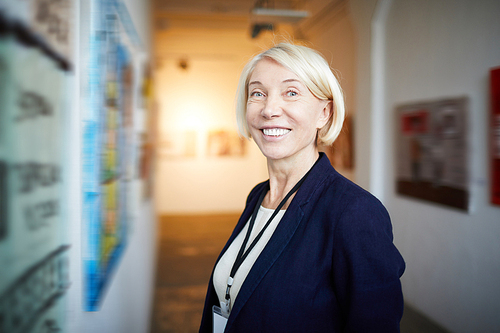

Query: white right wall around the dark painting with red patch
[[351, 0, 500, 332]]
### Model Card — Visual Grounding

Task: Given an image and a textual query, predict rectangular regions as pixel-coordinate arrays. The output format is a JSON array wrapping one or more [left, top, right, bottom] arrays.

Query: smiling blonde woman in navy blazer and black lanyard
[[200, 43, 405, 333]]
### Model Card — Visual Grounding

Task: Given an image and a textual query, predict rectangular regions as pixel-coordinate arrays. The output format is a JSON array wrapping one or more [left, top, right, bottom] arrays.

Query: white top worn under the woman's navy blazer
[[213, 206, 286, 308]]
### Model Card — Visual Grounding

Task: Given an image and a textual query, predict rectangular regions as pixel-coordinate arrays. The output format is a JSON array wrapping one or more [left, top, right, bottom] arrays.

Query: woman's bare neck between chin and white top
[[262, 150, 319, 209]]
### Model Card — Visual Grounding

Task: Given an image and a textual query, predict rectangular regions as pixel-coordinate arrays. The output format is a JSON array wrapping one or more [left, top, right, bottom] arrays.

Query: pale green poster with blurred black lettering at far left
[[0, 8, 71, 333]]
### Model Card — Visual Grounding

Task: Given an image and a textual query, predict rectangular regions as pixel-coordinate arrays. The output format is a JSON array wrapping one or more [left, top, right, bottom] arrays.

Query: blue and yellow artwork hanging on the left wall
[[82, 0, 141, 311]]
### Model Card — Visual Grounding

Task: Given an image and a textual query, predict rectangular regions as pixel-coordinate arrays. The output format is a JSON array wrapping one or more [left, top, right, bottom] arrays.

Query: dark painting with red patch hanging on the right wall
[[395, 97, 470, 211]]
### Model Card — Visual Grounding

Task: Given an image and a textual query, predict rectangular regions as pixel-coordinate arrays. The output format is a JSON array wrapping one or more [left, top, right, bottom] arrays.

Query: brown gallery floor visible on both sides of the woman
[[151, 214, 447, 333]]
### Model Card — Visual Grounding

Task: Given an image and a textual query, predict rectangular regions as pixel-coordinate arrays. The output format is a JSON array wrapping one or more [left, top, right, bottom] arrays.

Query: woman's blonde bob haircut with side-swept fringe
[[236, 43, 345, 146]]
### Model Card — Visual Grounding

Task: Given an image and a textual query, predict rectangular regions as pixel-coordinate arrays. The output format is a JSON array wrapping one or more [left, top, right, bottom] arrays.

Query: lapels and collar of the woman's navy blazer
[[225, 153, 335, 330]]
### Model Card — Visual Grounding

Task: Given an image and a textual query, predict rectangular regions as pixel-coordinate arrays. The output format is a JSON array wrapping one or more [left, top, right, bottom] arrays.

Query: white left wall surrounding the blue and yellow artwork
[[64, 0, 157, 333]]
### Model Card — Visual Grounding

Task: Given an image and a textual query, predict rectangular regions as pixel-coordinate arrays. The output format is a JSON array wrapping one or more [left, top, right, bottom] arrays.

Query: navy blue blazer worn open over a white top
[[200, 154, 405, 333]]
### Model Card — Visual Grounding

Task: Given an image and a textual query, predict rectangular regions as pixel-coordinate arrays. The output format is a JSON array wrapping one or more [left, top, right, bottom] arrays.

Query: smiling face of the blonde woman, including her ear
[[246, 58, 331, 164]]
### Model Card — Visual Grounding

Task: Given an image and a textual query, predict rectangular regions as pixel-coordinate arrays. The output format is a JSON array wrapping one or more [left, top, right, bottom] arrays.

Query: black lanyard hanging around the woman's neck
[[225, 158, 319, 313]]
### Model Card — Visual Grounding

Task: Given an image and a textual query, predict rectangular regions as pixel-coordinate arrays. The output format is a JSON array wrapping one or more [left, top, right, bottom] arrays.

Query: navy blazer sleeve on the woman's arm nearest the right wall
[[332, 193, 405, 333]]
